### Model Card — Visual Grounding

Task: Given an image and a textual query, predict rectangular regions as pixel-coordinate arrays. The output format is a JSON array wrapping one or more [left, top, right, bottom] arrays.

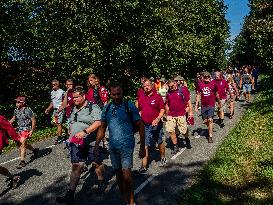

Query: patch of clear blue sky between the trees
[[224, 0, 249, 40]]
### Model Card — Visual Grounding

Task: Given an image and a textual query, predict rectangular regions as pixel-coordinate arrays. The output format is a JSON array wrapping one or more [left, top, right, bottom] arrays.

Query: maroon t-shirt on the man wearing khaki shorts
[[166, 87, 190, 117]]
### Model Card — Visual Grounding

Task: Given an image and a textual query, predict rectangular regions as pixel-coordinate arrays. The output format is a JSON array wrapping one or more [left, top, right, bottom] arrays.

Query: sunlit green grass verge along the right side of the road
[[178, 77, 273, 205]]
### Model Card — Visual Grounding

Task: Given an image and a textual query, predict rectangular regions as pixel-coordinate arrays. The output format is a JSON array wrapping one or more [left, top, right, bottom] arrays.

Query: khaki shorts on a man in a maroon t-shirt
[[166, 116, 188, 135]]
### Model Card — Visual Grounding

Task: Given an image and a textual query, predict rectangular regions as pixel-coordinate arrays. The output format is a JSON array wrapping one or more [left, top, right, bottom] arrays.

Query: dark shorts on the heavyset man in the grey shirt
[[69, 143, 103, 164]]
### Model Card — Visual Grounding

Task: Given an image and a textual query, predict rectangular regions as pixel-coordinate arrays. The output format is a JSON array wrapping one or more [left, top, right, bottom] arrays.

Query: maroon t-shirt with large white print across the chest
[[197, 81, 217, 107]]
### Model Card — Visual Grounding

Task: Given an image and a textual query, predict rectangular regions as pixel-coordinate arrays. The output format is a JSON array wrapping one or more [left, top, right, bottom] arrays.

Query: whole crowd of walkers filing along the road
[[0, 66, 258, 205]]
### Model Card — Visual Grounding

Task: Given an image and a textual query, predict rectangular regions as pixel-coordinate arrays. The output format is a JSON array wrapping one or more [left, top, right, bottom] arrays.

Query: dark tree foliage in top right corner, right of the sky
[[231, 0, 273, 68]]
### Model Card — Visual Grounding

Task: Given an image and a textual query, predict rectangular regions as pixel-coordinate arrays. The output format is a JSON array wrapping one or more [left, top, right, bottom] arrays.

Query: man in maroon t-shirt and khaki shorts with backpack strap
[[165, 80, 193, 154]]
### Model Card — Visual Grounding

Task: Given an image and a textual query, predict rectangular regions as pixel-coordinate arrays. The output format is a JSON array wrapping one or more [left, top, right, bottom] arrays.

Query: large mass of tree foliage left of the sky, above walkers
[[0, 0, 228, 125]]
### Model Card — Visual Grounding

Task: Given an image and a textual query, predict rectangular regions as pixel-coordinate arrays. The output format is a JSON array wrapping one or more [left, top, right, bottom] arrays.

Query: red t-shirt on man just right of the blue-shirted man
[[138, 91, 164, 124]]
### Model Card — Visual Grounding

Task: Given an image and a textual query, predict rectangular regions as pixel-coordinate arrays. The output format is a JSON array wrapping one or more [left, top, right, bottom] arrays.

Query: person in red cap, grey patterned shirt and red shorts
[[10, 97, 39, 169]]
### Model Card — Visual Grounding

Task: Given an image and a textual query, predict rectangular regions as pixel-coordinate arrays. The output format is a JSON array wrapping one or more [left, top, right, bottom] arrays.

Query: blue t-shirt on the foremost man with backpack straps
[[101, 101, 140, 149]]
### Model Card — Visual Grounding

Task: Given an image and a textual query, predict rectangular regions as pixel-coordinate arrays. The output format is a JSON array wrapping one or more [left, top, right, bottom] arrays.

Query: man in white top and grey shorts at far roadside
[[45, 79, 64, 144]]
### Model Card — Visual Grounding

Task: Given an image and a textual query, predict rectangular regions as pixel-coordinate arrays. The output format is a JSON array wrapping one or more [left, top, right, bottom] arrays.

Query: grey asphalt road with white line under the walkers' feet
[[0, 95, 252, 205]]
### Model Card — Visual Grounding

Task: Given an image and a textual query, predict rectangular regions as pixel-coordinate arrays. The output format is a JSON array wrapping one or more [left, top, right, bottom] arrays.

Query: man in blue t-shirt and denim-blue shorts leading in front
[[95, 83, 145, 205]]
